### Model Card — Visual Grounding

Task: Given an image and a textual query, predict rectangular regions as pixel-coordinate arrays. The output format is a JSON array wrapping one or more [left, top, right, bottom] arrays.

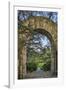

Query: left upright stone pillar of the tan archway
[[18, 31, 27, 79]]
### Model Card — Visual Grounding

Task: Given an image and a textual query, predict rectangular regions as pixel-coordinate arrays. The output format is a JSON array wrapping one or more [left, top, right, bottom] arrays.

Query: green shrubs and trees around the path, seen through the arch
[[27, 48, 51, 72]]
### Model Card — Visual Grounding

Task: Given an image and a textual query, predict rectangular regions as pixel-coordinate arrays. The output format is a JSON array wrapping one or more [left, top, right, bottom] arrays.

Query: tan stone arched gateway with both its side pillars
[[18, 16, 57, 79]]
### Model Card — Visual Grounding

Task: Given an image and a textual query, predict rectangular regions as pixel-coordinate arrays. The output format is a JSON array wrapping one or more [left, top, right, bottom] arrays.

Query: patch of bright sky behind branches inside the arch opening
[[29, 33, 51, 53]]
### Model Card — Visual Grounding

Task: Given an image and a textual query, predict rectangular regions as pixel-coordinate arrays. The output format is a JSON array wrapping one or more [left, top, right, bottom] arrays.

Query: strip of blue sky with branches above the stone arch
[[18, 10, 58, 23]]
